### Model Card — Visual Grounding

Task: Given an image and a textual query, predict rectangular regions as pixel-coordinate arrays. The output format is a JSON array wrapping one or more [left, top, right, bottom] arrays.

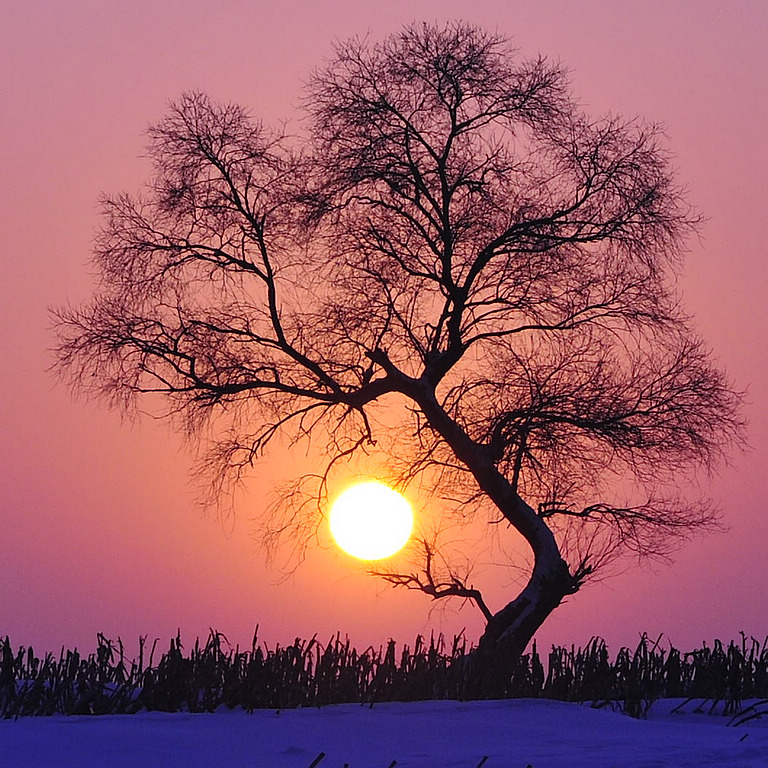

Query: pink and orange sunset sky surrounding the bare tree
[[0, 0, 768, 650]]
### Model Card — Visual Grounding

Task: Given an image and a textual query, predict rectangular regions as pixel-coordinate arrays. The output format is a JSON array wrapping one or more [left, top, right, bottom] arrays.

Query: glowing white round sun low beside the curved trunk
[[330, 480, 413, 560]]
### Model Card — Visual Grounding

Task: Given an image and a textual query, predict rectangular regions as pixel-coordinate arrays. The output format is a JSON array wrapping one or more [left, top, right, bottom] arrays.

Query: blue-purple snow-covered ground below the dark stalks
[[0, 700, 768, 768]]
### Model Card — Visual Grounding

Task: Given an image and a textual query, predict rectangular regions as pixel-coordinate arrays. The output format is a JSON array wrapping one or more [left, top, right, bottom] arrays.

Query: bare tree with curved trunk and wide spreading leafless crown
[[58, 24, 741, 654]]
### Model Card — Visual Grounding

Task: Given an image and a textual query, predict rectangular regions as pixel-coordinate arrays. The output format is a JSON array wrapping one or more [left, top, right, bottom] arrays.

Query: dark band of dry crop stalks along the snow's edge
[[0, 631, 768, 722]]
